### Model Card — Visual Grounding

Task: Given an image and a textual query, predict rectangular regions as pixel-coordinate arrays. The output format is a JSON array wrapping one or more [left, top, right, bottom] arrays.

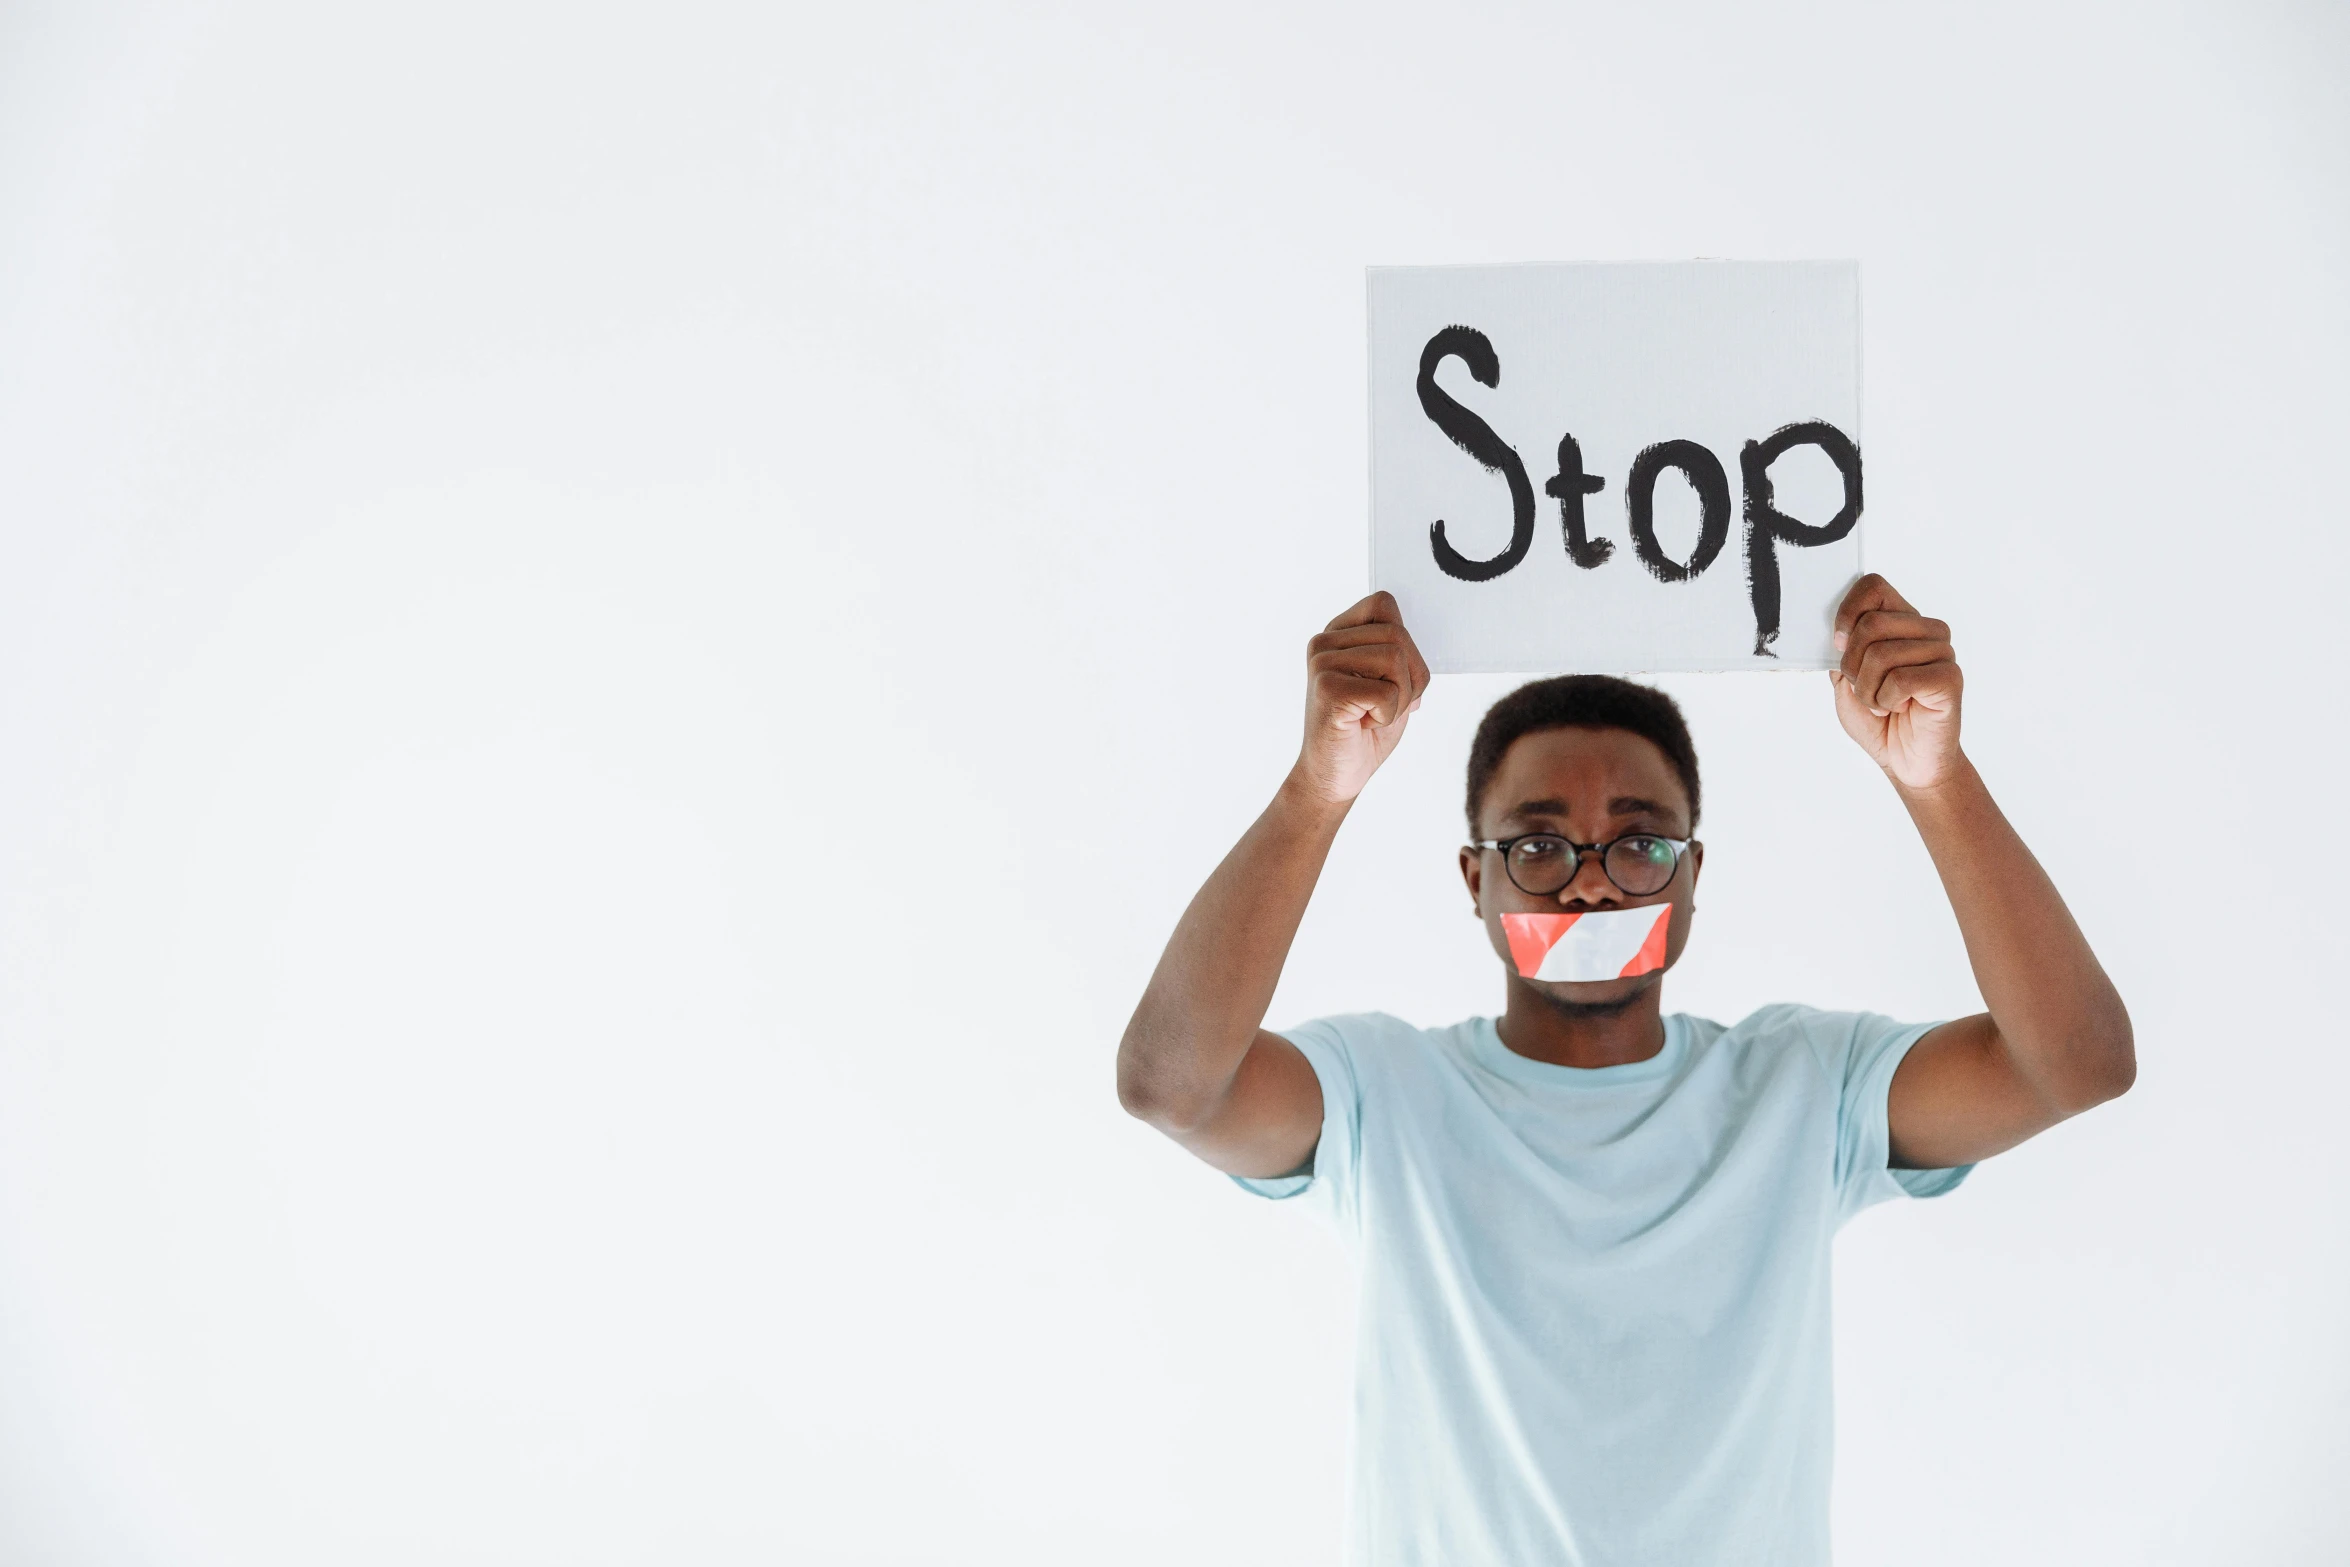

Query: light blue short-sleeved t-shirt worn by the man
[[1241, 1006, 1974, 1567]]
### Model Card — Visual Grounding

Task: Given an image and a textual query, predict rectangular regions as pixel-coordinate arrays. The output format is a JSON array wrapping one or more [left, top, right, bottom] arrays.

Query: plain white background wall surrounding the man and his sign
[[0, 0, 2350, 1567]]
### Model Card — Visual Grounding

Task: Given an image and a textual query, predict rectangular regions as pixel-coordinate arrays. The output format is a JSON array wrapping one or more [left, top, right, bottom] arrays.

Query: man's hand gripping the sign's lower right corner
[[1828, 573, 1965, 789]]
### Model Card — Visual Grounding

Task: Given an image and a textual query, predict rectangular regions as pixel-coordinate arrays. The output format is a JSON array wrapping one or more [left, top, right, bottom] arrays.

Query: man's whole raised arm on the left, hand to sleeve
[[1119, 592, 1429, 1177]]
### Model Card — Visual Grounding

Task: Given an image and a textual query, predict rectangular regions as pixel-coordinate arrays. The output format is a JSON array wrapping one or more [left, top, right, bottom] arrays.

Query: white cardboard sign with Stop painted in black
[[1370, 261, 1861, 672]]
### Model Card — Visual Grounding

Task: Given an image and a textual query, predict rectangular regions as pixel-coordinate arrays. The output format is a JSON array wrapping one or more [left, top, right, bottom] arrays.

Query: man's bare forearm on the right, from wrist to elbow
[[1894, 761, 2136, 1114]]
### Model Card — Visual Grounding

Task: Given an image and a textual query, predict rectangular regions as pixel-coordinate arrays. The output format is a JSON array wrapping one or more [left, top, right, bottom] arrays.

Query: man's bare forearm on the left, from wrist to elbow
[[1119, 771, 1351, 1123]]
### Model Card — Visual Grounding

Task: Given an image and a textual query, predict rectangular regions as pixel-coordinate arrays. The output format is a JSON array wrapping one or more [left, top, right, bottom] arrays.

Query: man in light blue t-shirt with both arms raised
[[1119, 576, 2136, 1567]]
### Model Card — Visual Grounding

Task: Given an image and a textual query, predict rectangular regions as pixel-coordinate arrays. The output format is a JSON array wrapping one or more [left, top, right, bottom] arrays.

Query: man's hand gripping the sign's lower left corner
[[1297, 590, 1429, 806]]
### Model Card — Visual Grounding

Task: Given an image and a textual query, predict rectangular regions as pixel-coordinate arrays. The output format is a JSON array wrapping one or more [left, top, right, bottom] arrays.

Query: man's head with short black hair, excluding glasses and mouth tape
[[1462, 674, 1704, 1013]]
